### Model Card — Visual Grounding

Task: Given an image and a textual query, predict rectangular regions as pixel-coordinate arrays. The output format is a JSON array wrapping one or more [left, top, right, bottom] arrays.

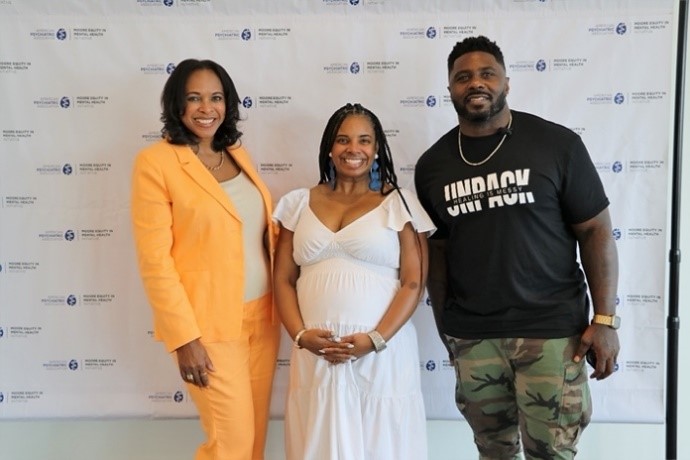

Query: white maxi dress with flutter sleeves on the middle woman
[[274, 189, 434, 460]]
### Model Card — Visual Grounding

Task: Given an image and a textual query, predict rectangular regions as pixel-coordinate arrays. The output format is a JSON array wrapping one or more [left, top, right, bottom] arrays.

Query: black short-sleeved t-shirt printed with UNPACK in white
[[415, 111, 609, 338]]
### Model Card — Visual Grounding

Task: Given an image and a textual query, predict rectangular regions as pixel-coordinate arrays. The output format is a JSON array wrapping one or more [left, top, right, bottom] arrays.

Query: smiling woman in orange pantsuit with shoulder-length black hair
[[132, 59, 279, 460]]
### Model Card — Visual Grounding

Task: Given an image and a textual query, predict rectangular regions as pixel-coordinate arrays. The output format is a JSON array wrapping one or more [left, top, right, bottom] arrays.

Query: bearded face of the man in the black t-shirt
[[448, 51, 510, 123]]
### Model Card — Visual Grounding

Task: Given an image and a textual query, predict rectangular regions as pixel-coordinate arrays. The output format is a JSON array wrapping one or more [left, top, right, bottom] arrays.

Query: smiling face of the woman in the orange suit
[[182, 69, 225, 143]]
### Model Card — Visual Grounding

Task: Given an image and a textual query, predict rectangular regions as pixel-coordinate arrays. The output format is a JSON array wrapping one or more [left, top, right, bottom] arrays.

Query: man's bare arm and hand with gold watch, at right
[[572, 209, 620, 380]]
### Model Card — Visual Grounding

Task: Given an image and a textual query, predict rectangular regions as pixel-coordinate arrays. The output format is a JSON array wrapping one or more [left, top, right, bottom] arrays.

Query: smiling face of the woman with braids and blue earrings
[[331, 115, 376, 181]]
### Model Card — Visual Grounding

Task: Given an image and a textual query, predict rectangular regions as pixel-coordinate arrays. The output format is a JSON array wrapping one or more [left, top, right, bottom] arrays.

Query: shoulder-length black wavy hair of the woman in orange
[[161, 59, 242, 151]]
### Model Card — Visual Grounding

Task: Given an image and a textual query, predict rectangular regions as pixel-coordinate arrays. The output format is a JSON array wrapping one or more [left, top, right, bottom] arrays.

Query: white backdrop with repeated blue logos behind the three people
[[0, 0, 677, 423]]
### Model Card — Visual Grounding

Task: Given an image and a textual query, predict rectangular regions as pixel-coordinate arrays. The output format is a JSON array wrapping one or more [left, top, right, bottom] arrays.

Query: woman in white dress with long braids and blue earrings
[[274, 104, 434, 460]]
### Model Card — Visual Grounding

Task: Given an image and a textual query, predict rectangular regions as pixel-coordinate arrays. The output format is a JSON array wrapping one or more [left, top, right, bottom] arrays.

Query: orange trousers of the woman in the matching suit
[[187, 295, 280, 460]]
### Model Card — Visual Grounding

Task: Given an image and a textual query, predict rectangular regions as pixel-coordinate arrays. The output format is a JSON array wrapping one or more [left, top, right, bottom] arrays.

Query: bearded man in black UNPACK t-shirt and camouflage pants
[[415, 36, 620, 459]]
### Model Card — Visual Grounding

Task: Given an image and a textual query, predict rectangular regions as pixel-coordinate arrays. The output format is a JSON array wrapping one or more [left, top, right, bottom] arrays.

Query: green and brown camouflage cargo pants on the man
[[446, 336, 592, 460]]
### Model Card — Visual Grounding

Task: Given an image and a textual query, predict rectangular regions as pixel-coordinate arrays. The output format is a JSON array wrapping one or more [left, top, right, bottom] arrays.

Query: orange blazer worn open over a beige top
[[132, 140, 276, 351]]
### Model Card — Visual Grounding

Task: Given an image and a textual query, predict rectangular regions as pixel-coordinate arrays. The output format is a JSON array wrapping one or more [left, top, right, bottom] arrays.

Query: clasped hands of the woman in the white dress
[[299, 329, 374, 364]]
